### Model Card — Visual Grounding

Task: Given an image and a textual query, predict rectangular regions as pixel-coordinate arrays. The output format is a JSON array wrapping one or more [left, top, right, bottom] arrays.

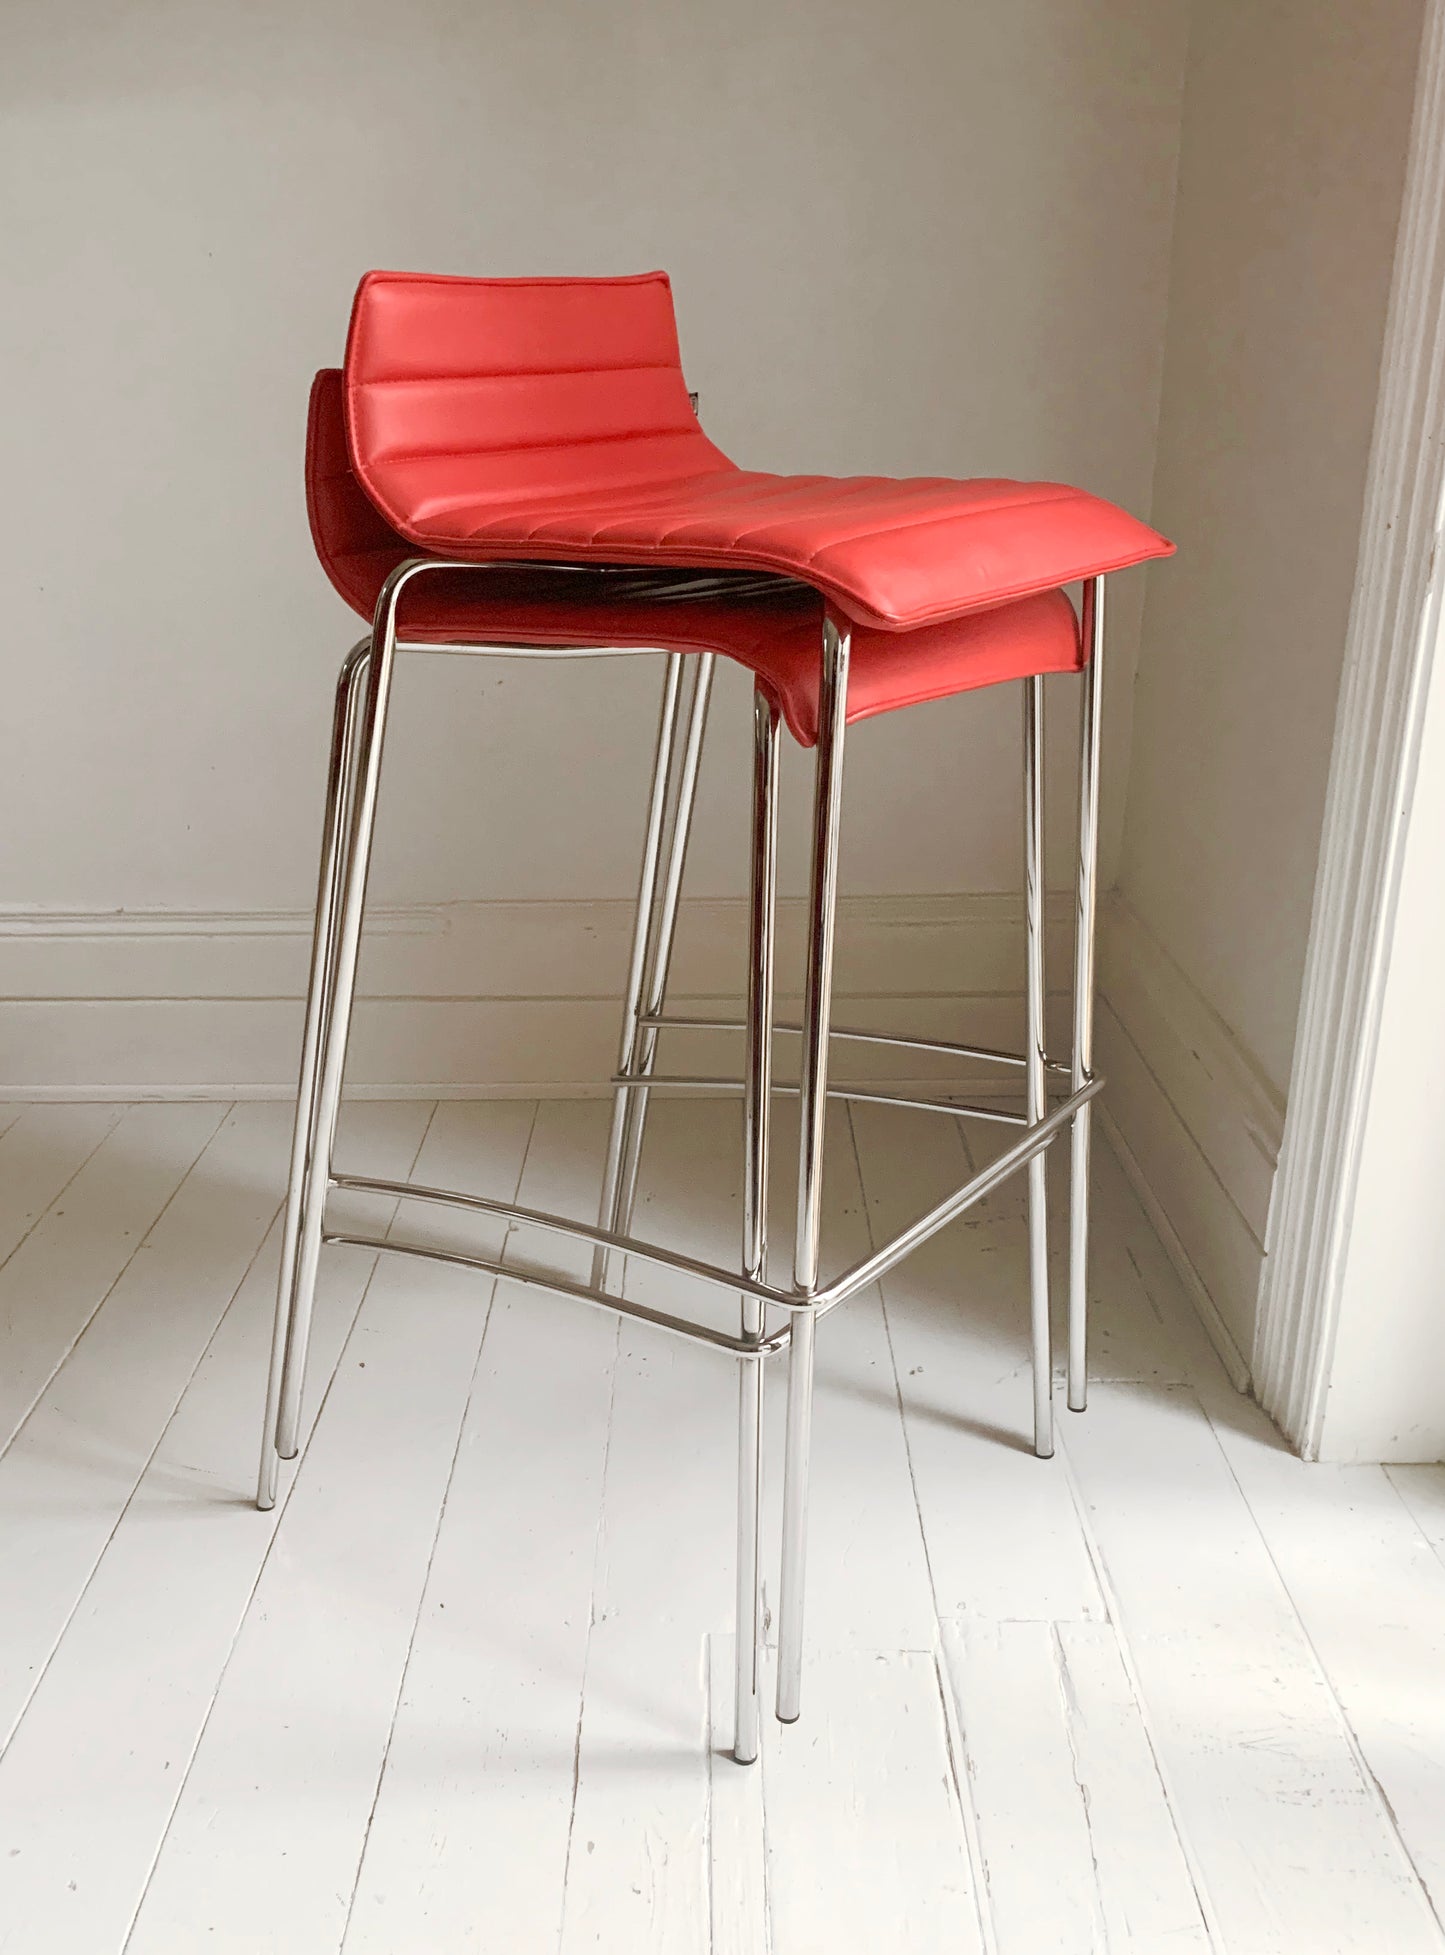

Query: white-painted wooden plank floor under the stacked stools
[[0, 1101, 1445, 1955]]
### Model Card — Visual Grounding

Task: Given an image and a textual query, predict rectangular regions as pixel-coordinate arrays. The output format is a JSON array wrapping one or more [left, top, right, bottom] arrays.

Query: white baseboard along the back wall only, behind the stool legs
[[0, 895, 1070, 1101]]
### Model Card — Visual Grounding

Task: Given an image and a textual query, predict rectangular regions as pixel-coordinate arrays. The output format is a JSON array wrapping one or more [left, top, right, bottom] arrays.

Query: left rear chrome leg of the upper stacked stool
[[276, 567, 409, 1460]]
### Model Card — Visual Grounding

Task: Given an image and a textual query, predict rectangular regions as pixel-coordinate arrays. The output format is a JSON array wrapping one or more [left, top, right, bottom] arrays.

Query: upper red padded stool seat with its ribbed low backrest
[[346, 272, 1173, 631]]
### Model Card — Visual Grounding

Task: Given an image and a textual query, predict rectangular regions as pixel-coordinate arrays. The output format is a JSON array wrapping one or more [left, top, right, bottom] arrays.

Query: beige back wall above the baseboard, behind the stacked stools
[[0, 0, 1185, 913]]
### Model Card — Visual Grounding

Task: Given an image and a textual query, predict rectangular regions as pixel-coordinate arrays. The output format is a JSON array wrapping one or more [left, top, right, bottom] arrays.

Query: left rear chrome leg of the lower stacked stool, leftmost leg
[[256, 637, 372, 1511]]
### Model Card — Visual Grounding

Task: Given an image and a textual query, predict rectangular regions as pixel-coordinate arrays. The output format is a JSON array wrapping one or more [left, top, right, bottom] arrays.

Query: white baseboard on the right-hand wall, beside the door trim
[[1097, 895, 1285, 1390]]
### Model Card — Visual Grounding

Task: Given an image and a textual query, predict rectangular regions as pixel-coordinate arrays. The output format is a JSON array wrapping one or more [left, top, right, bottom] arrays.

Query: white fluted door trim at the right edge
[[1253, 0, 1445, 1458]]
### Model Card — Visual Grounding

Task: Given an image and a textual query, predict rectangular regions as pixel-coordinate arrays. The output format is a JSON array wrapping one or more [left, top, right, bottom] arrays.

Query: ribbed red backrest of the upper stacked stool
[[344, 272, 731, 536]]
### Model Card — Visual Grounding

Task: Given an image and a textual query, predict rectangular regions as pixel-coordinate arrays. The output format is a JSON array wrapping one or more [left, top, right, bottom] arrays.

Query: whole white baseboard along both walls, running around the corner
[[0, 893, 1281, 1384]]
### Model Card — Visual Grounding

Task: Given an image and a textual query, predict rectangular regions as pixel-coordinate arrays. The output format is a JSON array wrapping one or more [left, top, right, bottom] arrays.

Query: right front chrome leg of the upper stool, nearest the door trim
[[1070, 577, 1105, 1412]]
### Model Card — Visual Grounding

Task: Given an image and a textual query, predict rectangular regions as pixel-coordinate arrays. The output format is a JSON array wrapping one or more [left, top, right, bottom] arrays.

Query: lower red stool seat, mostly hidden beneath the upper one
[[307, 369, 1081, 747]]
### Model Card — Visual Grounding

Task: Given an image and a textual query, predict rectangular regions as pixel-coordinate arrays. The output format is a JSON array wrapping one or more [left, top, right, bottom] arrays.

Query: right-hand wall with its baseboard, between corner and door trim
[[1101, 0, 1422, 1376]]
